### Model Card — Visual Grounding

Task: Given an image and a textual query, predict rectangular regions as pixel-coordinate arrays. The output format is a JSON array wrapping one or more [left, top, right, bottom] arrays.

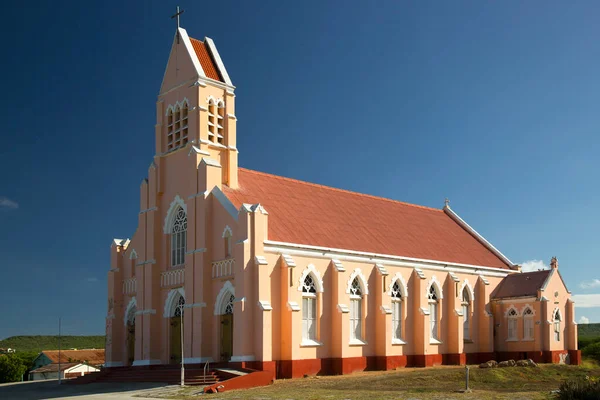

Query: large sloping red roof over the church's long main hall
[[223, 168, 509, 269]]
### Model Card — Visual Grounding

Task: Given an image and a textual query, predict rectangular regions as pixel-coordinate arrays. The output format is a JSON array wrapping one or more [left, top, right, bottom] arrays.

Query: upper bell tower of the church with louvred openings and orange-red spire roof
[[156, 21, 238, 188]]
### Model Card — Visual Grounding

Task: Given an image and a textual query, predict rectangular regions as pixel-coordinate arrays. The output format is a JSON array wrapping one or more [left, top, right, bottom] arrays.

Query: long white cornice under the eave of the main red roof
[[264, 240, 517, 277]]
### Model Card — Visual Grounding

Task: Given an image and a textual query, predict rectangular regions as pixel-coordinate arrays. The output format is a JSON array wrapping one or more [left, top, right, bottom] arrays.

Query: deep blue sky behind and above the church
[[0, 1, 600, 338]]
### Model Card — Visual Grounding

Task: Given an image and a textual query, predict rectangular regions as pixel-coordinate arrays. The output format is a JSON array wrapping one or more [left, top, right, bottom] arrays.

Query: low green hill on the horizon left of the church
[[0, 335, 104, 353]]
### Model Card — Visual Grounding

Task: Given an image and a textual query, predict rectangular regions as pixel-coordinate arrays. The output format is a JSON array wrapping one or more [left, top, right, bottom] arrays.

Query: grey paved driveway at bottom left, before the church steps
[[0, 380, 174, 400]]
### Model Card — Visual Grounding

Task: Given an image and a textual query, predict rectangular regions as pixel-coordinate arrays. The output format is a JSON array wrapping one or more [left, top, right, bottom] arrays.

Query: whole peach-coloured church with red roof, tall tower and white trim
[[106, 24, 580, 378]]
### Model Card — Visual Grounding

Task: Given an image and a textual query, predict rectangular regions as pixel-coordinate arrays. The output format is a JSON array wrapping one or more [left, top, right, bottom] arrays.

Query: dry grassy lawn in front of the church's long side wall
[[173, 361, 600, 400]]
